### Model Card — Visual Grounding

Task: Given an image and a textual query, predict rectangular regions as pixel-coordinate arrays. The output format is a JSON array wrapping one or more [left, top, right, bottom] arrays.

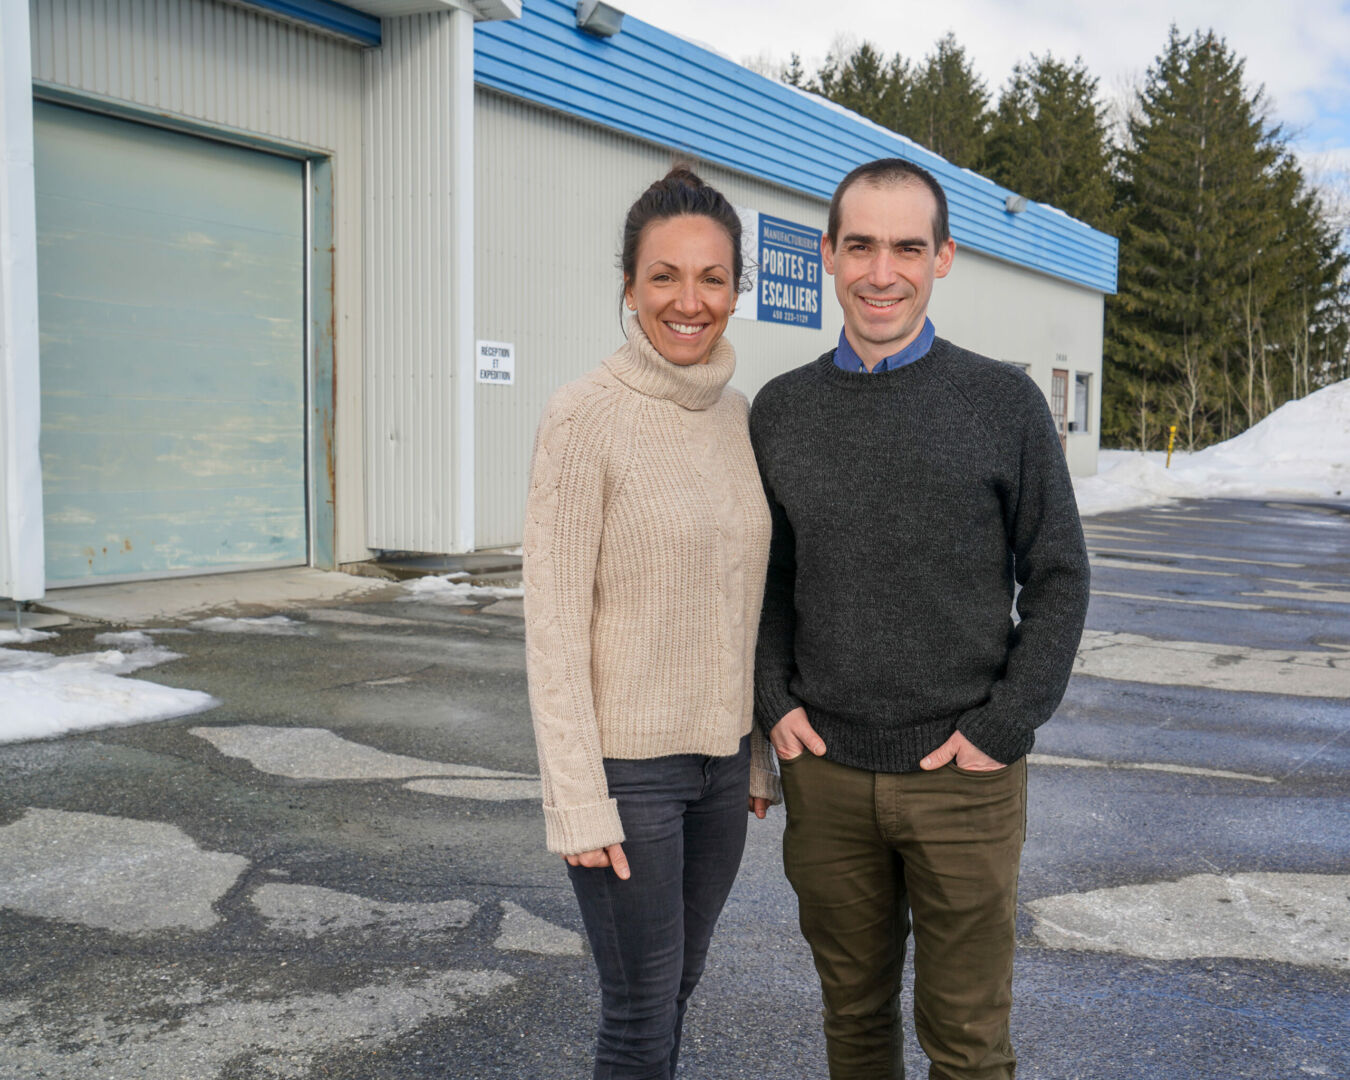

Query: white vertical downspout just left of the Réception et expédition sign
[[450, 7, 477, 554]]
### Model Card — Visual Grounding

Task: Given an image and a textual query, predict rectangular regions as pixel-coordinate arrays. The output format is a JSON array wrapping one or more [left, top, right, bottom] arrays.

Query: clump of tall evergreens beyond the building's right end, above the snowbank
[[1103, 27, 1347, 448]]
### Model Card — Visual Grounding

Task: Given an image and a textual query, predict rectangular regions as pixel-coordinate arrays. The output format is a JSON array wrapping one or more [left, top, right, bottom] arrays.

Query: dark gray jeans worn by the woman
[[568, 736, 751, 1080]]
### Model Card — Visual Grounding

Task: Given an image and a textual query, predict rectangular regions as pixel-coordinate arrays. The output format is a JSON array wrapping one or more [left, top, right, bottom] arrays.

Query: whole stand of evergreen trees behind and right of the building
[[772, 27, 1350, 450]]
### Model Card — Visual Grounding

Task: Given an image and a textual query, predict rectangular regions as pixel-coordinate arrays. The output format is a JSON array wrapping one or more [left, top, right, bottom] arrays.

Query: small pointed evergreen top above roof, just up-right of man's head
[[888, 34, 990, 169]]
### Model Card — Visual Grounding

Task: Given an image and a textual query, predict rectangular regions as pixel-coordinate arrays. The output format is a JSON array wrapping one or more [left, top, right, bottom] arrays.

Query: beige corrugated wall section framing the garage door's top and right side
[[30, 0, 367, 562]]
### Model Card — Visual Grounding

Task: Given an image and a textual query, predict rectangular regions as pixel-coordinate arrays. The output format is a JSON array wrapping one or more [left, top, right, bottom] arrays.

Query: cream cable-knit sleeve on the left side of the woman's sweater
[[524, 386, 624, 855]]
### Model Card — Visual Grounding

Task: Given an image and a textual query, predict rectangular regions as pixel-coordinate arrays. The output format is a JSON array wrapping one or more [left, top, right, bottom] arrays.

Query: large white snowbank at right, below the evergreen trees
[[1073, 379, 1350, 517]]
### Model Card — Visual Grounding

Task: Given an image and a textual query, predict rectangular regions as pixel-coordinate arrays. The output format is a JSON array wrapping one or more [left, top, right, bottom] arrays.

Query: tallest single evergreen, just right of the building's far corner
[[1103, 27, 1280, 448]]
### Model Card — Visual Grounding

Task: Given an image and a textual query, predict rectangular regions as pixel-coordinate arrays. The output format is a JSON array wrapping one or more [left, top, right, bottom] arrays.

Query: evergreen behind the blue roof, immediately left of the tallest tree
[[984, 54, 1115, 231]]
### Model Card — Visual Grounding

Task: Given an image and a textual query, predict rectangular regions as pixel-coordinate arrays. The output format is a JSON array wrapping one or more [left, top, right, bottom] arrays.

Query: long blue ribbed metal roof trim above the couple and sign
[[477, 0, 1118, 293]]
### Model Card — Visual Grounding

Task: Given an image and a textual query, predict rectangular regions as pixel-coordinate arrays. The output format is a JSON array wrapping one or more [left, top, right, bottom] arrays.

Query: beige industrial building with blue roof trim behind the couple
[[0, 0, 1116, 601]]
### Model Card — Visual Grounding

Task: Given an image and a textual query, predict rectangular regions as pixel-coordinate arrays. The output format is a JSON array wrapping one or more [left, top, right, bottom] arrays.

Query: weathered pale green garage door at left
[[34, 103, 308, 586]]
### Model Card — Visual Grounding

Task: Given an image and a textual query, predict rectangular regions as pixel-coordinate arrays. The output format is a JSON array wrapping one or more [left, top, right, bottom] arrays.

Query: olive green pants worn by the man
[[780, 753, 1026, 1080]]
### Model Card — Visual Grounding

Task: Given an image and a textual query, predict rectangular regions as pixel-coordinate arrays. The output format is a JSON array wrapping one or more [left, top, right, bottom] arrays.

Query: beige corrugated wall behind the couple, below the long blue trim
[[475, 88, 1102, 548]]
